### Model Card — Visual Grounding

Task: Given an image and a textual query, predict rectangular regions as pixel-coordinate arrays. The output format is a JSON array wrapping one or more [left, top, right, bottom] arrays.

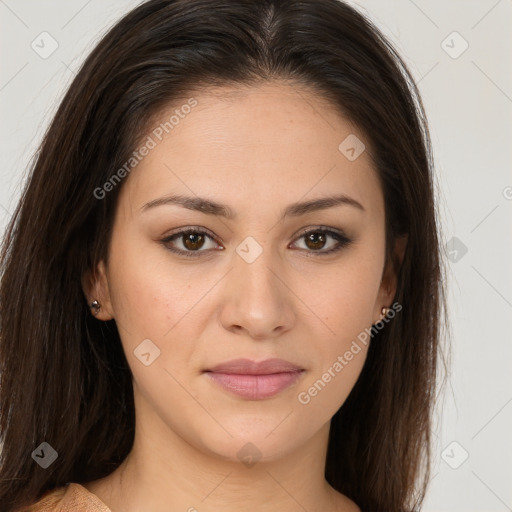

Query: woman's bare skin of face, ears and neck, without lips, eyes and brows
[[83, 82, 405, 512]]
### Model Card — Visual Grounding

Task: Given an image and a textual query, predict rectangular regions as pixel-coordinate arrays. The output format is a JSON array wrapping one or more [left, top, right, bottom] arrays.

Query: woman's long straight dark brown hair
[[0, 0, 446, 512]]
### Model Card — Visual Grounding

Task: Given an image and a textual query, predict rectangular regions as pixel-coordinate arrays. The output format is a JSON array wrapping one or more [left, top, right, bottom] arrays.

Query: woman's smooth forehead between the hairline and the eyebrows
[[120, 83, 383, 221]]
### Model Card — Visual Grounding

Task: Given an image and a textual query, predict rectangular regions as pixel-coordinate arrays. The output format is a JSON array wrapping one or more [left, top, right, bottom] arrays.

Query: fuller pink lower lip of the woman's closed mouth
[[207, 370, 303, 400]]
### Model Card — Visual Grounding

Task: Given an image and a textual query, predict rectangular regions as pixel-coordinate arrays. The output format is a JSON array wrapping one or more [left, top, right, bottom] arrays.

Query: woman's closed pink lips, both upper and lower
[[206, 359, 304, 400]]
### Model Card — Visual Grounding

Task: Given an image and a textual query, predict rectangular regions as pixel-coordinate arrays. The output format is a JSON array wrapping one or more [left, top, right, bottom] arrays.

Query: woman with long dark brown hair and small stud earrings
[[0, 0, 445, 512]]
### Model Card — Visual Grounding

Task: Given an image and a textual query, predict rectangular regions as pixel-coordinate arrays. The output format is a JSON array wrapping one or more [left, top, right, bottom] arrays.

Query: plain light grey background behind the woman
[[0, 0, 512, 512]]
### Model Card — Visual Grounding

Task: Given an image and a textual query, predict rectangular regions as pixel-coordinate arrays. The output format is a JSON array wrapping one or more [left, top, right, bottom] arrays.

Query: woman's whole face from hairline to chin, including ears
[[85, 83, 402, 460]]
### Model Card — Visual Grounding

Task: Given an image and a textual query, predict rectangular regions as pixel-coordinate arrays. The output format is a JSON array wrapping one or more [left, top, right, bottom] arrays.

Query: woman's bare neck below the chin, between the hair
[[84, 386, 359, 512]]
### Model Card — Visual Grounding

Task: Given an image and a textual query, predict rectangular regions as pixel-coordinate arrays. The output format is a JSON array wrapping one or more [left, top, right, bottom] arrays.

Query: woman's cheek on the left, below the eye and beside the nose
[[106, 233, 219, 388]]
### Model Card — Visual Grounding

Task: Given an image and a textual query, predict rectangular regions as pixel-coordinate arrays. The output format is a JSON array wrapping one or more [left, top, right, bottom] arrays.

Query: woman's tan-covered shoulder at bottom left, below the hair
[[18, 483, 111, 512]]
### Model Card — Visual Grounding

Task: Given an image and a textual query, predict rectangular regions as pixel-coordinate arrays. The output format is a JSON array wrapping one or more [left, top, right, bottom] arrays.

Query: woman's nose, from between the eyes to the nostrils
[[220, 244, 296, 340]]
